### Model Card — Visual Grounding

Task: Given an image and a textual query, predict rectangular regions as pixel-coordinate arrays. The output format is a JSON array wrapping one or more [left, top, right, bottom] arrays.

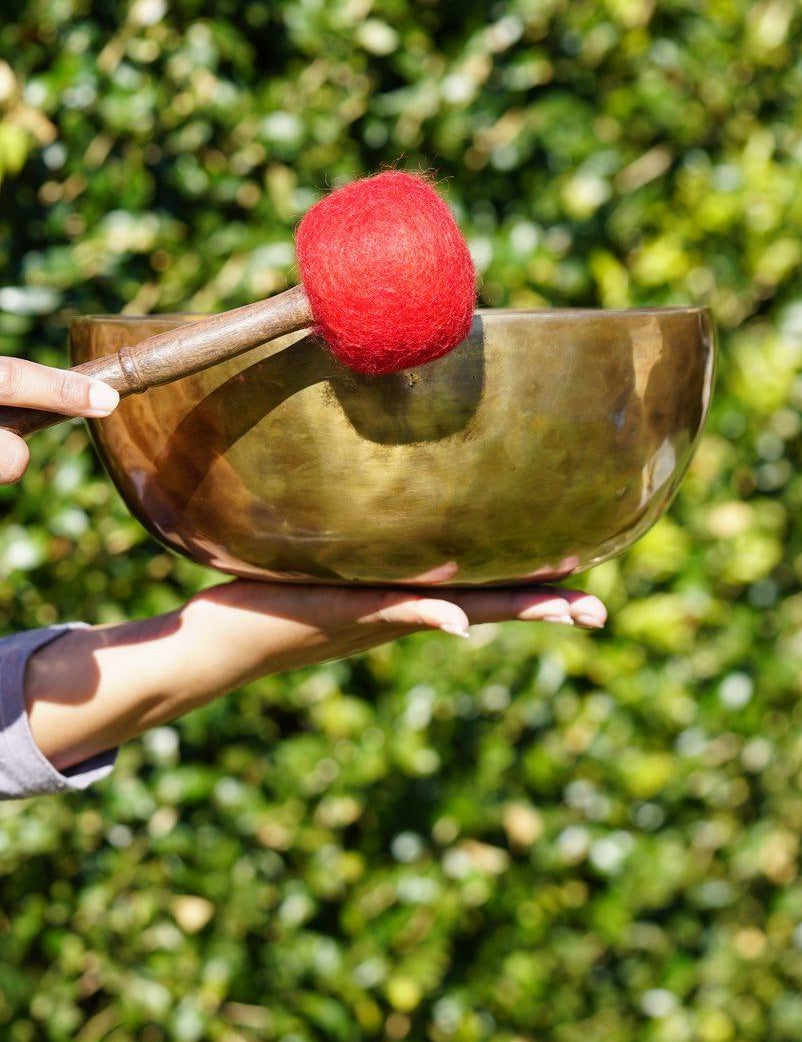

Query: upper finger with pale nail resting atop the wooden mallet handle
[[0, 356, 120, 417]]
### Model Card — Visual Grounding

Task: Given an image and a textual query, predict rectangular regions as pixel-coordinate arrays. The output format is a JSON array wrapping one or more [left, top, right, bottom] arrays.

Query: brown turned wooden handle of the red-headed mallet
[[0, 286, 315, 438]]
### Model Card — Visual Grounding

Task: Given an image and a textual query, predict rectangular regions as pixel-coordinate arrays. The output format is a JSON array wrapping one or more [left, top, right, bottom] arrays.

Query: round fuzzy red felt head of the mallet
[[296, 170, 476, 375]]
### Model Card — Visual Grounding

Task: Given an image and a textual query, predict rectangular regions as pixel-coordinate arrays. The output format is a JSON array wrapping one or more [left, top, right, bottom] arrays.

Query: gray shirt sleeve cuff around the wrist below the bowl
[[0, 623, 117, 800]]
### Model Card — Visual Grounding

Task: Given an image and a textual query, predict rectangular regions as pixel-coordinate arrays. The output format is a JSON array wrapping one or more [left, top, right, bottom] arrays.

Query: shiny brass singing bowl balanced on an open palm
[[71, 307, 715, 586]]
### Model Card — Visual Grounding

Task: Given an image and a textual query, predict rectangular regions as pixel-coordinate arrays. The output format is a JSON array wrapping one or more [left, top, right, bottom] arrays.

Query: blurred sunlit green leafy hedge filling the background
[[0, 0, 802, 1042]]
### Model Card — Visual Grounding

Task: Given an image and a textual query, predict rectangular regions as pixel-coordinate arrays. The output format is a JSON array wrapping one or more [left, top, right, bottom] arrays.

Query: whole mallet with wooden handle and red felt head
[[0, 171, 476, 437]]
